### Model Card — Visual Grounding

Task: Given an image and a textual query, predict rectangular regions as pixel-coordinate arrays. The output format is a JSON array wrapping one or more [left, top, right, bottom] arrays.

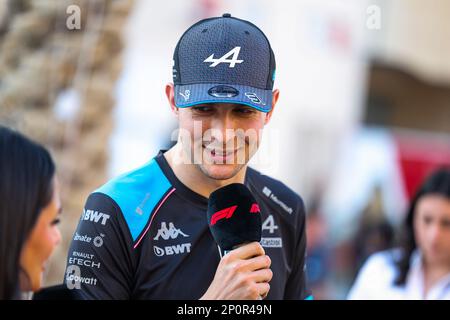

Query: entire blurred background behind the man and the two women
[[0, 0, 450, 299]]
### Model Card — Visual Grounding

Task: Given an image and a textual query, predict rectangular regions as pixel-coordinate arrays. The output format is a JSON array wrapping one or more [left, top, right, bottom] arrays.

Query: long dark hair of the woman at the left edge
[[0, 126, 55, 300]]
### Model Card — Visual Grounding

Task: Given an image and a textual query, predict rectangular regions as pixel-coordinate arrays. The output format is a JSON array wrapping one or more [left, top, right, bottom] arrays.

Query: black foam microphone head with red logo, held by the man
[[207, 183, 262, 255]]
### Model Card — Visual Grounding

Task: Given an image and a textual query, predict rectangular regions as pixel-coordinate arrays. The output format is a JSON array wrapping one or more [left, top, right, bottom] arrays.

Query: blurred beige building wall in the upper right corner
[[369, 0, 450, 85]]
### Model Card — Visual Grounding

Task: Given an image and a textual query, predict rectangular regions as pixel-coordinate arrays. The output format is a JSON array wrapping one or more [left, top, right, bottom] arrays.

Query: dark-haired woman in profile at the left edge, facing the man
[[0, 126, 61, 299]]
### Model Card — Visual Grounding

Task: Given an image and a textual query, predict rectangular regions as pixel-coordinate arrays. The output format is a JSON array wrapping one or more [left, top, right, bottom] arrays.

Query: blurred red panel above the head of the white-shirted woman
[[394, 135, 450, 200]]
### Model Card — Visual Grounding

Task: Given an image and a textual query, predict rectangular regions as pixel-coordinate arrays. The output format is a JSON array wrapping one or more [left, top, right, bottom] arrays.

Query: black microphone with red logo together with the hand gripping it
[[201, 183, 273, 300]]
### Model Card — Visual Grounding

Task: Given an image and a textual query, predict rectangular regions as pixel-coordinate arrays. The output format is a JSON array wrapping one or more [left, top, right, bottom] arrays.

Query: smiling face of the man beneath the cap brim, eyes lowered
[[178, 103, 270, 180]]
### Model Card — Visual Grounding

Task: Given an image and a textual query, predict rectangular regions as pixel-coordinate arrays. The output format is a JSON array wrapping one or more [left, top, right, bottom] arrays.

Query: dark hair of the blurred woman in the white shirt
[[394, 167, 450, 286]]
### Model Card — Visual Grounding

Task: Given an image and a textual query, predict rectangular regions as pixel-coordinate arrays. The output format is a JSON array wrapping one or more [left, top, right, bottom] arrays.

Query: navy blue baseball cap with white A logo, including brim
[[173, 13, 275, 112]]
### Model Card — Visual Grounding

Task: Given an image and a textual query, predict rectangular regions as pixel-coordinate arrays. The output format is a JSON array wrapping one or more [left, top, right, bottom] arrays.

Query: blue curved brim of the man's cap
[[175, 83, 272, 112]]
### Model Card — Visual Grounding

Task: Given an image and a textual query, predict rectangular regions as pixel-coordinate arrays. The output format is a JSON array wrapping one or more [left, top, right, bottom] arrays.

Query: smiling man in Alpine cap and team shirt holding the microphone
[[66, 14, 308, 299]]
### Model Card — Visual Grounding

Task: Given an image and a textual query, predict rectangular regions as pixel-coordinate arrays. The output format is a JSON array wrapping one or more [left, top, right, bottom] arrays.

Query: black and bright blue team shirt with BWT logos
[[65, 151, 308, 299]]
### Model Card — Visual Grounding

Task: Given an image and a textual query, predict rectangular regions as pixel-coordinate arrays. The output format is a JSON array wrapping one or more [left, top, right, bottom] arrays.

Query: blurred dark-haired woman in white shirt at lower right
[[348, 168, 450, 300]]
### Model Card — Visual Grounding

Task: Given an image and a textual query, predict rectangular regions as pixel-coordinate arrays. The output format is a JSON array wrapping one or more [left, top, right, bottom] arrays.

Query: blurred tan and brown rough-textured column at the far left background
[[0, 0, 133, 284]]
